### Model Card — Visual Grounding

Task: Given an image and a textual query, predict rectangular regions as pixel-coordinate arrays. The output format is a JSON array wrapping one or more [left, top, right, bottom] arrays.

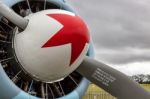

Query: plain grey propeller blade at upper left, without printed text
[[0, 1, 28, 30]]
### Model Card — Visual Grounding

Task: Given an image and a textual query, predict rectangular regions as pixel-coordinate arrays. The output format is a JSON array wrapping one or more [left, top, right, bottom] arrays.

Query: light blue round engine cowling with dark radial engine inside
[[0, 0, 93, 99]]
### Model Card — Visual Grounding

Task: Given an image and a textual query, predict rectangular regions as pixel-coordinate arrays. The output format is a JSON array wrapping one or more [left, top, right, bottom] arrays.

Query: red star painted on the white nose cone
[[42, 14, 90, 65]]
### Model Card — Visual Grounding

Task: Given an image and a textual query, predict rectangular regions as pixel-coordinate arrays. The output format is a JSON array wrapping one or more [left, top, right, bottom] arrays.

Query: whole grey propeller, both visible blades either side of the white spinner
[[0, 1, 150, 99]]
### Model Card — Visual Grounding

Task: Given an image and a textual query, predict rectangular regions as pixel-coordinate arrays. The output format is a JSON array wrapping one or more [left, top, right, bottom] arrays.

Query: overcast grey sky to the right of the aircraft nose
[[67, 0, 150, 75]]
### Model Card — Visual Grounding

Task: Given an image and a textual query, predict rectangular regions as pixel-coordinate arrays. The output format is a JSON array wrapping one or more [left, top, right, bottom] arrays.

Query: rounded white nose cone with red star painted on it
[[14, 10, 90, 82]]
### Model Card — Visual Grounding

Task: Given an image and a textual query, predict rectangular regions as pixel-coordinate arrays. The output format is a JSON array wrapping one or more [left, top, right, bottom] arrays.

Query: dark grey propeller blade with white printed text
[[77, 57, 150, 99]]
